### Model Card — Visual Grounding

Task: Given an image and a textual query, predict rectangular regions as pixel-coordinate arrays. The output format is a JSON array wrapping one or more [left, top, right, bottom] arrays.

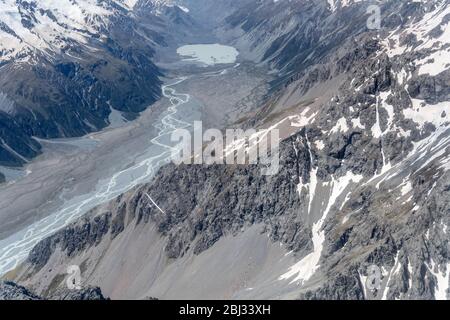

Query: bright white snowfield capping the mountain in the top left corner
[[0, 0, 134, 61]]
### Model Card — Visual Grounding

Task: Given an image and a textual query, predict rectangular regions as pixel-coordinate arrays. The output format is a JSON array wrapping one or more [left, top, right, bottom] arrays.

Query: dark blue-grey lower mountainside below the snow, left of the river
[[0, 3, 175, 166]]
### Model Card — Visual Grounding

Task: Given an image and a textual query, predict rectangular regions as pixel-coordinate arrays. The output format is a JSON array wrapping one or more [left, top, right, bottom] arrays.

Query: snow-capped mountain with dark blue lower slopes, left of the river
[[0, 0, 197, 166]]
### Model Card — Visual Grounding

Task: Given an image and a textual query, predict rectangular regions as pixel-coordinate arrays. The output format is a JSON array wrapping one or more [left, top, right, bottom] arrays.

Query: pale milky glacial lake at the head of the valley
[[177, 43, 239, 66]]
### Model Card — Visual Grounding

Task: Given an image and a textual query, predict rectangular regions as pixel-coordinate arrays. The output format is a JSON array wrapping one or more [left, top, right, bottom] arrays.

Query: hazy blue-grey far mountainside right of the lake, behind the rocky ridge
[[224, 0, 446, 80]]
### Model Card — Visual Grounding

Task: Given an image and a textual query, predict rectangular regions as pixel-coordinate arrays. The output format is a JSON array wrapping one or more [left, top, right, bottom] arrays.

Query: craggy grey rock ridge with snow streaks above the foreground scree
[[7, 2, 450, 299]]
